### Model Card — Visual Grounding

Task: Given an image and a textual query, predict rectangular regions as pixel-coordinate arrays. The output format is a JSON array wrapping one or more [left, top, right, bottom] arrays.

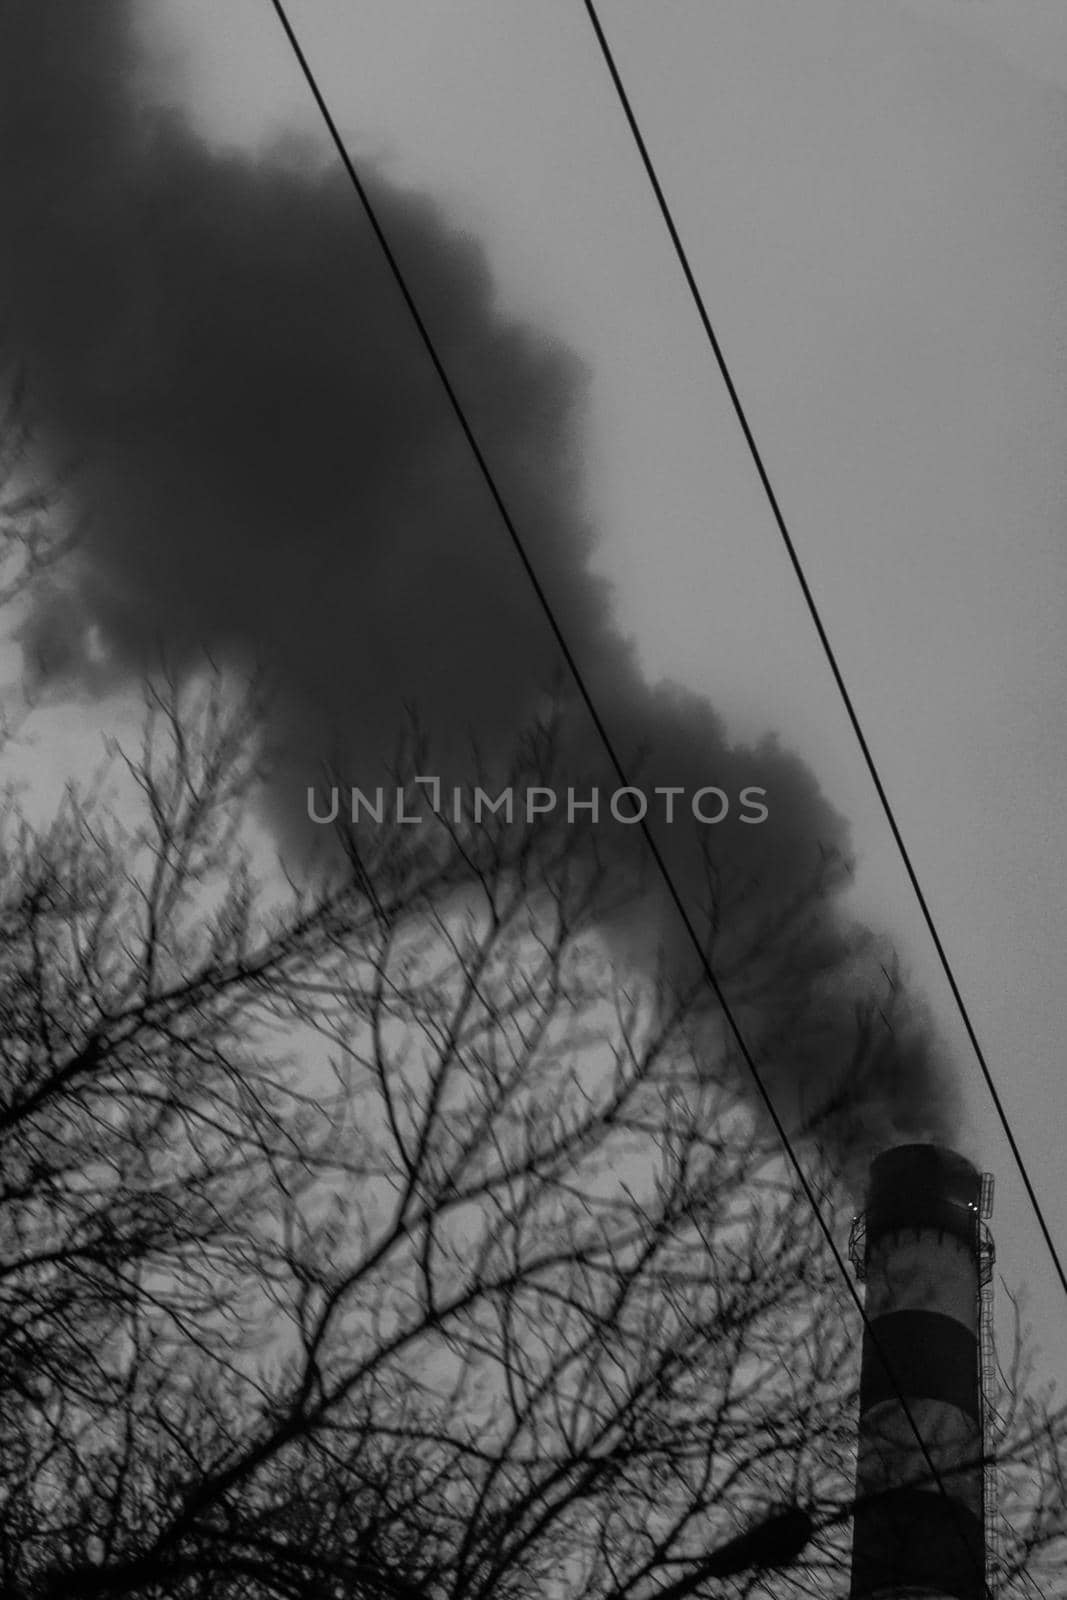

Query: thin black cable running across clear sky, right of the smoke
[[582, 0, 1067, 1294]]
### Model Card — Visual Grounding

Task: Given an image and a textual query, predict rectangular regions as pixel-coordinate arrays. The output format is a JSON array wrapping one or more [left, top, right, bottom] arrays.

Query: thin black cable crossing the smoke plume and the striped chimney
[[262, 0, 992, 1600]]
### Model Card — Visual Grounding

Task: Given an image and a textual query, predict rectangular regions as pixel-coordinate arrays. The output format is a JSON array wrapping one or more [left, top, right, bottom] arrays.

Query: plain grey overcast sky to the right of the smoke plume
[[8, 0, 1067, 1371]]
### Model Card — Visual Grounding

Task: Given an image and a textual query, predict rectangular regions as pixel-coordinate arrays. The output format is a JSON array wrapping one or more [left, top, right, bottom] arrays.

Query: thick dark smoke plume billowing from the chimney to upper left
[[0, 0, 952, 1164]]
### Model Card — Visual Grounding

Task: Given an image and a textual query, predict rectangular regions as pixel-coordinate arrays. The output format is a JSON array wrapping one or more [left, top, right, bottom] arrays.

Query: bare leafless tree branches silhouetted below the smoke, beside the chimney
[[0, 675, 1064, 1600]]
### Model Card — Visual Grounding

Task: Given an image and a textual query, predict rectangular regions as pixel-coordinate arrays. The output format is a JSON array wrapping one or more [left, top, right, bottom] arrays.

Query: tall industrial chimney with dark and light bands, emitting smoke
[[849, 1144, 993, 1600]]
